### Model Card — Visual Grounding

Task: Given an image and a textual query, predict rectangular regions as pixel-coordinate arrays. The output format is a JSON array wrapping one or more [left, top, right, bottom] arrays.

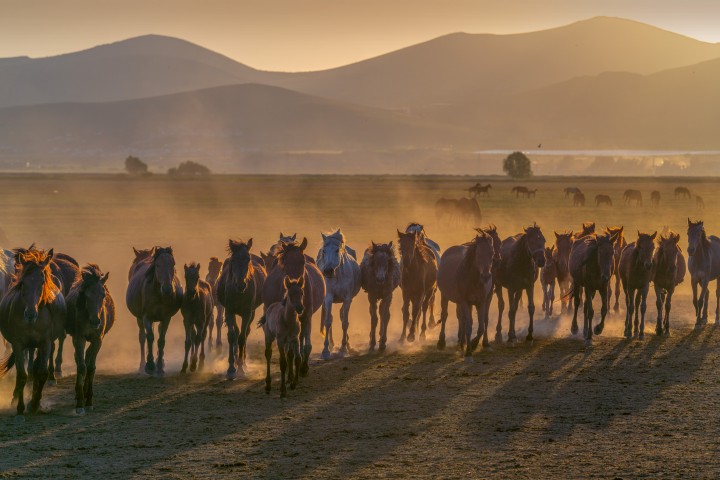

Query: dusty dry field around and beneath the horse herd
[[0, 175, 720, 479]]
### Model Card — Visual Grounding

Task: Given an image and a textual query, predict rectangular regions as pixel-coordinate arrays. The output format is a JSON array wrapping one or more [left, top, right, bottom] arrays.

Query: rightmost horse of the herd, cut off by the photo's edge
[[687, 218, 720, 327]]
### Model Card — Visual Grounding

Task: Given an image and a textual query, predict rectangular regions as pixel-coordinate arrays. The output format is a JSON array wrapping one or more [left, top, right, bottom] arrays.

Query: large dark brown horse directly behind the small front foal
[[262, 238, 325, 376]]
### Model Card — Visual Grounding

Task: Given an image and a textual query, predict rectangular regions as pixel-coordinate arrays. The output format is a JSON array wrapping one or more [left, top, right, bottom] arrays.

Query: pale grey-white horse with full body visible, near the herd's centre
[[315, 229, 362, 360]]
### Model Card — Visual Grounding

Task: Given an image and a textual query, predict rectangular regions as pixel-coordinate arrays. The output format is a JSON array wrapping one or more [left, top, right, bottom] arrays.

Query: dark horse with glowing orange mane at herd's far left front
[[0, 250, 67, 415]]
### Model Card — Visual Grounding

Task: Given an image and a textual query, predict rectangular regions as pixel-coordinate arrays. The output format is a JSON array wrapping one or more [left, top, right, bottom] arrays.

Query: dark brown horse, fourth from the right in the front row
[[570, 233, 615, 345]]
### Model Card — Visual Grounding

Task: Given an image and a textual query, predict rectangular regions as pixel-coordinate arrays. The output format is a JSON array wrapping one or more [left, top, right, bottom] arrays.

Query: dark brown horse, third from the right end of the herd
[[618, 231, 657, 340]]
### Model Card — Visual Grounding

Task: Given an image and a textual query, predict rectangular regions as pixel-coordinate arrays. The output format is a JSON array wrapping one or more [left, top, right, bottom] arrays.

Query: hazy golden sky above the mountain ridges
[[0, 0, 720, 71]]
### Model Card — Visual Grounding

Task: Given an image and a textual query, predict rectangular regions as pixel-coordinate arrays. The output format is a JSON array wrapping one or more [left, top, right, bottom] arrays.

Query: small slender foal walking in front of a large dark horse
[[258, 275, 305, 397]]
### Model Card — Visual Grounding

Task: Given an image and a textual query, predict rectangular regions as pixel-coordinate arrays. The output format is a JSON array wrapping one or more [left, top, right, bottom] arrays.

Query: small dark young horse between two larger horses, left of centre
[[180, 263, 214, 373]]
